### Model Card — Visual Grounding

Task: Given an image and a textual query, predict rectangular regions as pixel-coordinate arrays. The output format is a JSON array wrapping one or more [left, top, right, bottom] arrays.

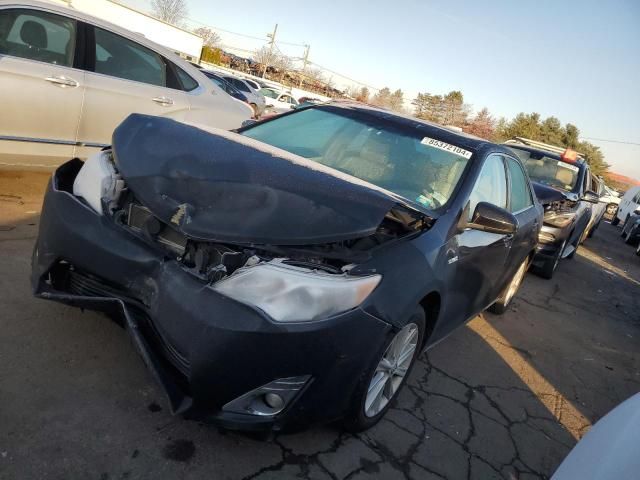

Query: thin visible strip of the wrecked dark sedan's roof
[[320, 101, 496, 151]]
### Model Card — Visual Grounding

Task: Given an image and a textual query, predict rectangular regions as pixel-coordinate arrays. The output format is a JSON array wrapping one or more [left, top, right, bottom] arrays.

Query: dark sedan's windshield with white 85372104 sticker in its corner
[[242, 108, 471, 209]]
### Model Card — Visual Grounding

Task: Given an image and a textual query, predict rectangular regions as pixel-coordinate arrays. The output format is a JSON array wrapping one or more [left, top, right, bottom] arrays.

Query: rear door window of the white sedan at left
[[94, 28, 167, 87]]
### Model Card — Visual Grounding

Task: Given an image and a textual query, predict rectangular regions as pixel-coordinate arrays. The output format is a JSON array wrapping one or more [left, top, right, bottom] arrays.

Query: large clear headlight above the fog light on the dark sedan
[[212, 261, 382, 322]]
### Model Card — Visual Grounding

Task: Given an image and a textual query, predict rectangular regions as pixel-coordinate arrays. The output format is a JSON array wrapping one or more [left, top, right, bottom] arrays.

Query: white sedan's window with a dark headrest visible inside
[[0, 9, 76, 67]]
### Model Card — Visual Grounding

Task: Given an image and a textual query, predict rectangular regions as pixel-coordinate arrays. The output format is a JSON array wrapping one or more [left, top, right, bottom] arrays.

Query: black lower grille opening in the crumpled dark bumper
[[66, 268, 191, 380]]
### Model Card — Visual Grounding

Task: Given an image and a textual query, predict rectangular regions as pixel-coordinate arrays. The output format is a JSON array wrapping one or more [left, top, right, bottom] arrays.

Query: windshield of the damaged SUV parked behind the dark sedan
[[509, 146, 580, 191]]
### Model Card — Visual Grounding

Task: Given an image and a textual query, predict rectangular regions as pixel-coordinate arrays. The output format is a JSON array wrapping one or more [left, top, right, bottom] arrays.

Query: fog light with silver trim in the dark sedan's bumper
[[222, 375, 311, 417]]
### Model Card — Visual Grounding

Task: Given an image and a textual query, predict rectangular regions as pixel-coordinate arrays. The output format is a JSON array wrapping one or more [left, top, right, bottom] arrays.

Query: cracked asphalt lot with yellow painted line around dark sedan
[[0, 171, 640, 480]]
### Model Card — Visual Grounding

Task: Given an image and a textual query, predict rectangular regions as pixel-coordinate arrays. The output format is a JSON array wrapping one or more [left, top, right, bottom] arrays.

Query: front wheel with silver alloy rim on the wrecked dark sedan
[[344, 306, 426, 432]]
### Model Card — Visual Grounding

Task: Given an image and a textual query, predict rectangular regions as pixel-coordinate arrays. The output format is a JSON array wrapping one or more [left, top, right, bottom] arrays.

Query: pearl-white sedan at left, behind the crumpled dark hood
[[0, 0, 251, 166]]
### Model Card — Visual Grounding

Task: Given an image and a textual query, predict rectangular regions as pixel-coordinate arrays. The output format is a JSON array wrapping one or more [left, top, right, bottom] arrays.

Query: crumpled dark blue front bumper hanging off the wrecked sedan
[[32, 162, 391, 429]]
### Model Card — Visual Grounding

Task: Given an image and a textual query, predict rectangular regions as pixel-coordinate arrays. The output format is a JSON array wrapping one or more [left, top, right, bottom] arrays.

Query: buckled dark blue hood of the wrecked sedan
[[113, 113, 407, 245]]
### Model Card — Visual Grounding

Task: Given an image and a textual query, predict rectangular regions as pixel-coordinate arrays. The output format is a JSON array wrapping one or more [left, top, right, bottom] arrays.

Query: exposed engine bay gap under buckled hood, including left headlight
[[73, 149, 430, 284]]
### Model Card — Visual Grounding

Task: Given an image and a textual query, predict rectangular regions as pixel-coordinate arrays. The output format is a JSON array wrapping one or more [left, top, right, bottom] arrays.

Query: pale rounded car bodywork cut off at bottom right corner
[[551, 394, 640, 480]]
